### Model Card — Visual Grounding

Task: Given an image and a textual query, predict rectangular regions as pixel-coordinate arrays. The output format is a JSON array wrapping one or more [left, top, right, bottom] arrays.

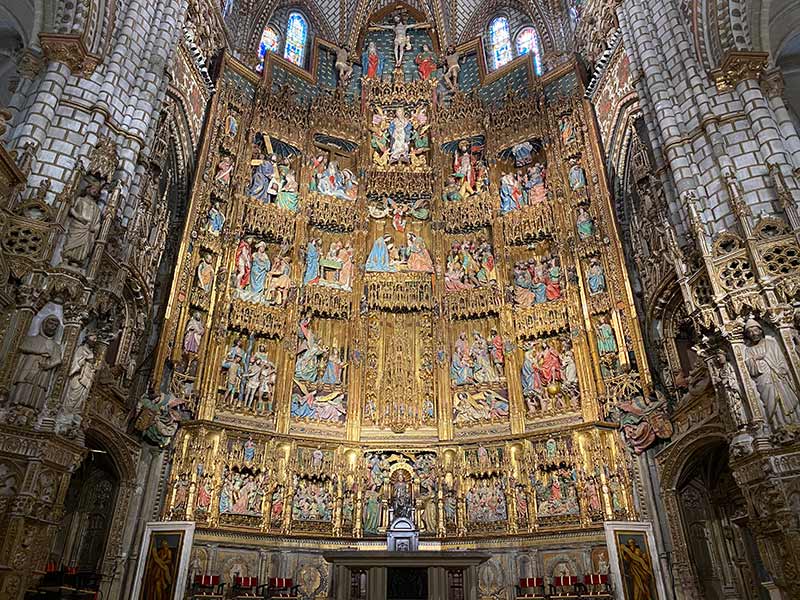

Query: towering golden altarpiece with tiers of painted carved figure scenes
[[155, 12, 652, 596]]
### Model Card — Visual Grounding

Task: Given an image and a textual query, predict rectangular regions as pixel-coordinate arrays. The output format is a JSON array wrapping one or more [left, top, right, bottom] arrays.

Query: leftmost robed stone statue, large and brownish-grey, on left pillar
[[10, 315, 62, 410]]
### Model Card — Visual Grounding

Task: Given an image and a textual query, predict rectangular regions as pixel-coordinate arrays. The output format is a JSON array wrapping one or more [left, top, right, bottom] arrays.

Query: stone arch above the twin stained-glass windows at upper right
[[458, 0, 557, 56]]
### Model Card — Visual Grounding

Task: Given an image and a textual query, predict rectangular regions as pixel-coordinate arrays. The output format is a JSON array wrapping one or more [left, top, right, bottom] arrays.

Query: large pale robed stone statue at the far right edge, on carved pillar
[[744, 319, 800, 429]]
